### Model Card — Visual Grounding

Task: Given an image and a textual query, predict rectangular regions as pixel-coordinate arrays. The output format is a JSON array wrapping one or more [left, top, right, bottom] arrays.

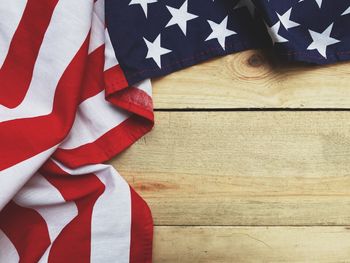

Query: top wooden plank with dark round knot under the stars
[[153, 50, 350, 109]]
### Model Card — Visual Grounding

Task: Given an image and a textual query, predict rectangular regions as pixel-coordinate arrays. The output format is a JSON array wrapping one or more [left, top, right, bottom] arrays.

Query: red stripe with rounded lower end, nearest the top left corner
[[0, 0, 58, 108]]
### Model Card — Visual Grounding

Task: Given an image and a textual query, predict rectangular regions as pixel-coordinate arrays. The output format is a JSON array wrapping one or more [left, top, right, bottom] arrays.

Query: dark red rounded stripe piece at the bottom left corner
[[0, 202, 50, 263]]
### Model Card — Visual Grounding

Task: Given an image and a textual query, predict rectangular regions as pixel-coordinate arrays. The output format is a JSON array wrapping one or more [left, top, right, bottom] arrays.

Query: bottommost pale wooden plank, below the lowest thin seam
[[154, 227, 350, 263]]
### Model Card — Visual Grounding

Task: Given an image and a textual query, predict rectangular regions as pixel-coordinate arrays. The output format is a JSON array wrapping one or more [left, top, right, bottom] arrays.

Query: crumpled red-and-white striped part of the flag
[[0, 0, 153, 263]]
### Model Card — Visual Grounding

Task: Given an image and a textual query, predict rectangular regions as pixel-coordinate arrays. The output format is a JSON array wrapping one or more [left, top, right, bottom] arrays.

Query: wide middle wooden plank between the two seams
[[112, 111, 350, 225]]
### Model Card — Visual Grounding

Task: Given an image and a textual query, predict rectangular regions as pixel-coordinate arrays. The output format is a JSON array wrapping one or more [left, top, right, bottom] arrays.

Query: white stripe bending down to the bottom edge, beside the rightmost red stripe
[[55, 161, 131, 263]]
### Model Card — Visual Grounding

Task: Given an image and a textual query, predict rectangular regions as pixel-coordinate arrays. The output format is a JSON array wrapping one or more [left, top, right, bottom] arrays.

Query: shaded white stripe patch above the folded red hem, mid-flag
[[60, 91, 130, 149]]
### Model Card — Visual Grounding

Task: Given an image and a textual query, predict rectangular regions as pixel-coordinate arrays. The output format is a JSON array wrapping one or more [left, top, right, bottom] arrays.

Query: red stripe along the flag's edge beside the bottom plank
[[130, 187, 153, 263]]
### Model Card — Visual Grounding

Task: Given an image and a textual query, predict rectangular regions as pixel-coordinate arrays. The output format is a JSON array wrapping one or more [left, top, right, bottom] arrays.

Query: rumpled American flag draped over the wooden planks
[[0, 0, 350, 263]]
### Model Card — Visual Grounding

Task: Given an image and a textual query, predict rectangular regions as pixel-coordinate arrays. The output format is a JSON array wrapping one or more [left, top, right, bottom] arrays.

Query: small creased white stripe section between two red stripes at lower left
[[13, 173, 78, 262]]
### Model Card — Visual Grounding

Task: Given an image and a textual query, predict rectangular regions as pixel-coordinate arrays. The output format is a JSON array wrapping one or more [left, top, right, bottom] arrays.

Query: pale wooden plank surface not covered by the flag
[[112, 51, 350, 263]]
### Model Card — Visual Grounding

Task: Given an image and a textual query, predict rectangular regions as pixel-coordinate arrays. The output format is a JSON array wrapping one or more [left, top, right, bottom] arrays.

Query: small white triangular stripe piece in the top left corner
[[0, 0, 27, 68]]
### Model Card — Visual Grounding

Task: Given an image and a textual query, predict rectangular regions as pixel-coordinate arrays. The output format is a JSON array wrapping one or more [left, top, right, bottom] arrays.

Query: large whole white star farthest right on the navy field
[[307, 23, 340, 58]]
